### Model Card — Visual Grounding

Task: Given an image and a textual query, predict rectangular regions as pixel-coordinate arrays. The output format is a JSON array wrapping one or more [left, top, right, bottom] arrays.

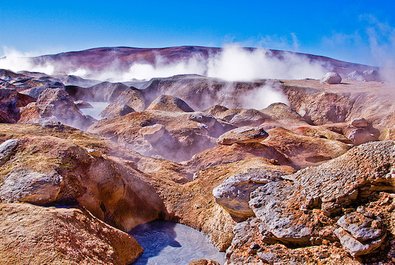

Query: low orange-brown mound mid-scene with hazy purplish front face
[[89, 107, 234, 161]]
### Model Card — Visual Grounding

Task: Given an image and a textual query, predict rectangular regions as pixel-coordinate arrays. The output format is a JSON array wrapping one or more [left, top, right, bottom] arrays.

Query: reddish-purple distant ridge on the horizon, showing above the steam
[[33, 46, 377, 74]]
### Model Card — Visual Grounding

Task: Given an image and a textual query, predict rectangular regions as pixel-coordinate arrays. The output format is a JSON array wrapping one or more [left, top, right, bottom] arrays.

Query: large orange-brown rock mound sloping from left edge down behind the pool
[[0, 124, 235, 254]]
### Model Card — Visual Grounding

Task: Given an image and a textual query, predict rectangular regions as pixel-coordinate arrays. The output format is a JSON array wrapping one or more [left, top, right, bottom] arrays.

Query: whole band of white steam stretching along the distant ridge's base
[[0, 44, 327, 81]]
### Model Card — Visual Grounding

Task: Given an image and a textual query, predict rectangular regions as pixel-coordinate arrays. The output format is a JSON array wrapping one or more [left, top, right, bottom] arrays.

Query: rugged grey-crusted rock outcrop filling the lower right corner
[[228, 141, 395, 264]]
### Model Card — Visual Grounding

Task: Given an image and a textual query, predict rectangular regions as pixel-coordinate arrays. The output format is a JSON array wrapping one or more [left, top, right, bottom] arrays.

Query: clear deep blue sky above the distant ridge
[[0, 0, 395, 64]]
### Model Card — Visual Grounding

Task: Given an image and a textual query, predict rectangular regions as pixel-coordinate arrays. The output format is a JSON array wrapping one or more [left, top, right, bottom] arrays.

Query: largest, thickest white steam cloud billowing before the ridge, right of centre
[[122, 45, 327, 81]]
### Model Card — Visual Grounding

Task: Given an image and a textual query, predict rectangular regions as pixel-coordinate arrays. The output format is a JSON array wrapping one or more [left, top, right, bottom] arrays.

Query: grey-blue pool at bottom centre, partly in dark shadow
[[131, 221, 225, 265]]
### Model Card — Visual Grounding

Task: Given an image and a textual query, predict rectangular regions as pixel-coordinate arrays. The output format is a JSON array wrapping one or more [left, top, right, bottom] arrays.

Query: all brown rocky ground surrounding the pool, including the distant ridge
[[0, 47, 395, 264]]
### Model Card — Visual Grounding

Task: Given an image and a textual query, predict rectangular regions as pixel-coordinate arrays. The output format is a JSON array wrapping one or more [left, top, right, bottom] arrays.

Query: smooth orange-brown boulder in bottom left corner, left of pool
[[0, 203, 143, 265]]
